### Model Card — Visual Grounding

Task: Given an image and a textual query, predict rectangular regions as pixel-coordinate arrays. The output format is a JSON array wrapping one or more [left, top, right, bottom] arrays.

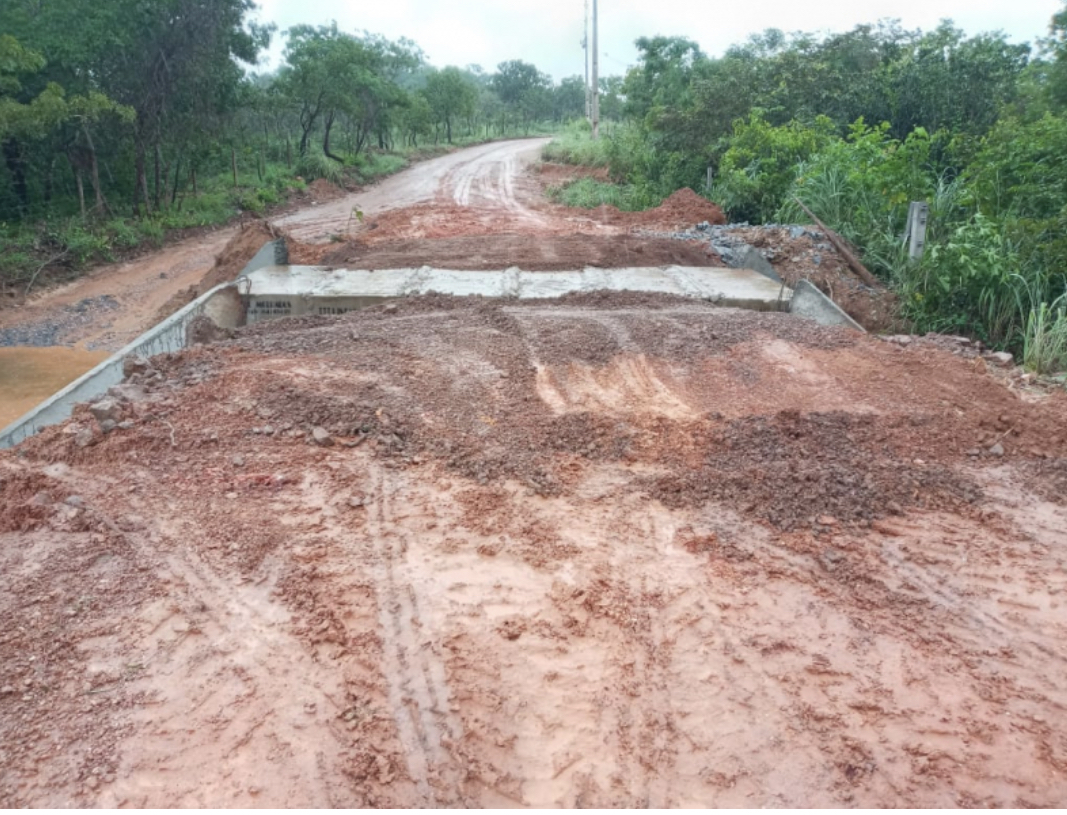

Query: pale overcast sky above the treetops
[[257, 0, 1062, 80]]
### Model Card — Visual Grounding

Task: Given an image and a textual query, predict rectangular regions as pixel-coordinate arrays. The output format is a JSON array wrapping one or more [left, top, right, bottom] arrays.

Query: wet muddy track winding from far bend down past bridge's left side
[[0, 139, 547, 427]]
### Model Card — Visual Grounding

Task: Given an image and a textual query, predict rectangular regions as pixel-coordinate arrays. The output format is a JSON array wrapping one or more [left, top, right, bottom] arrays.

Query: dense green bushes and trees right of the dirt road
[[547, 9, 1067, 370]]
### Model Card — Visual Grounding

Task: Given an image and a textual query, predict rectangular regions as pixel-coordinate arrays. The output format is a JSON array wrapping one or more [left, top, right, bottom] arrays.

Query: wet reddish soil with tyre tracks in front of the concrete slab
[[0, 293, 1067, 808]]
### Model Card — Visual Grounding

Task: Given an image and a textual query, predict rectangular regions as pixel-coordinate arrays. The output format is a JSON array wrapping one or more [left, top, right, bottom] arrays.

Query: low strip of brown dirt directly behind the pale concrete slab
[[308, 234, 721, 271]]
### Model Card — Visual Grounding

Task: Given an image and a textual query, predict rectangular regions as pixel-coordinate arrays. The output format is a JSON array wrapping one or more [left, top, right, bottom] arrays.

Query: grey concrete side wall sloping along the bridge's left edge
[[0, 238, 288, 448]]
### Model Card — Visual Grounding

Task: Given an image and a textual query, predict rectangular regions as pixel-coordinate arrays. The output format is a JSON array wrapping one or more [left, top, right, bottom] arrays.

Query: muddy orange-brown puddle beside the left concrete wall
[[0, 346, 111, 428]]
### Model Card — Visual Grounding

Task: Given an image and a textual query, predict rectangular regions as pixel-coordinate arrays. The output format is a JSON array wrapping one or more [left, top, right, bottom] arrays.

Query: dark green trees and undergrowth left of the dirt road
[[0, 0, 619, 290]]
